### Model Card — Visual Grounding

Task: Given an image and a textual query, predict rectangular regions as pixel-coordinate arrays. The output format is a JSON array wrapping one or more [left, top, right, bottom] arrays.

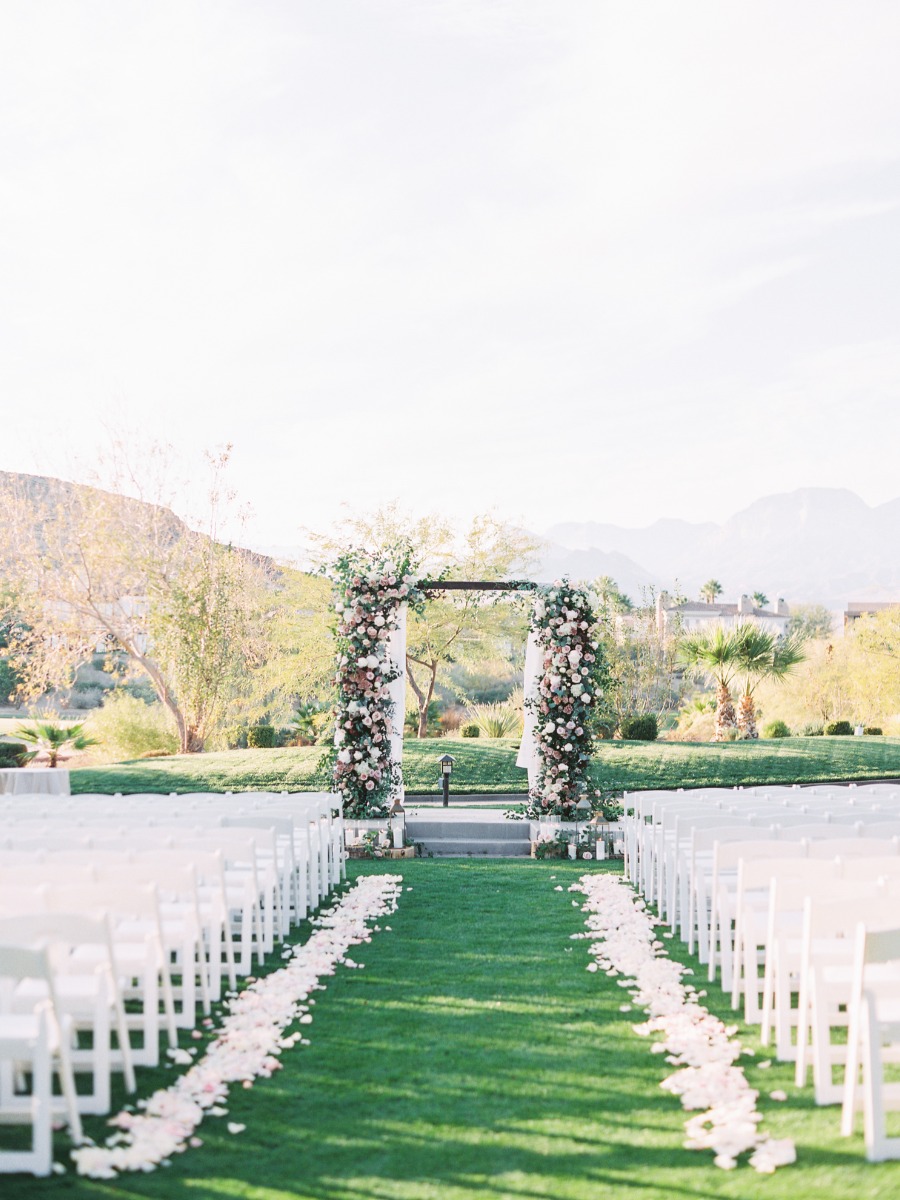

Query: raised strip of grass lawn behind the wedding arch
[[72, 738, 900, 794]]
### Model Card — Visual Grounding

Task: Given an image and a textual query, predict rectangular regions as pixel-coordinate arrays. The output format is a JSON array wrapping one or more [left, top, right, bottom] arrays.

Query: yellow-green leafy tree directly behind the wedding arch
[[316, 505, 538, 738]]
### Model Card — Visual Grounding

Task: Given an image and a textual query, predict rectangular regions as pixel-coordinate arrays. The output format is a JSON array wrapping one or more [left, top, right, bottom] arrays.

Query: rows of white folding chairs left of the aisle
[[0, 793, 346, 1174]]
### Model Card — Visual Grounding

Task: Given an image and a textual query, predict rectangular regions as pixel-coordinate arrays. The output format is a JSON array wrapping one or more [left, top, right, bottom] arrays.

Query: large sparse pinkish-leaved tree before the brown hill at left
[[0, 445, 272, 752]]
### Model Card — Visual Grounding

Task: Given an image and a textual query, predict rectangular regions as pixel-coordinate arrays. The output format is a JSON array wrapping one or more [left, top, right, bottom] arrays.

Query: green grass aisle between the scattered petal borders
[[8, 859, 900, 1200]]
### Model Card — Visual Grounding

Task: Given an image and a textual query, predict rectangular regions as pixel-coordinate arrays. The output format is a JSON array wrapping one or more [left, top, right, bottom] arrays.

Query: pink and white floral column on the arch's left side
[[326, 548, 425, 817]]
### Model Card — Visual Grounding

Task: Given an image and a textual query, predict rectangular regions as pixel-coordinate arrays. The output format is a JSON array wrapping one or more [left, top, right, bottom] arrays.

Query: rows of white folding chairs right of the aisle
[[626, 785, 900, 1159]]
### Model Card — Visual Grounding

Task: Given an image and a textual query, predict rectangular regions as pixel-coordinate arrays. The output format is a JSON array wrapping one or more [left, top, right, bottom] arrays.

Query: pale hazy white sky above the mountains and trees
[[0, 0, 900, 544]]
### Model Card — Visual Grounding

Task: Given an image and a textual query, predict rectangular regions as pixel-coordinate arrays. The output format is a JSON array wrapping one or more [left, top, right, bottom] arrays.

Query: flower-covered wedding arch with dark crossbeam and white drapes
[[329, 550, 605, 817]]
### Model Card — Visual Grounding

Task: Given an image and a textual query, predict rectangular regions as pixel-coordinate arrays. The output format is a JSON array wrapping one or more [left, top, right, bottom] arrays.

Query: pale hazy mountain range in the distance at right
[[545, 487, 900, 608]]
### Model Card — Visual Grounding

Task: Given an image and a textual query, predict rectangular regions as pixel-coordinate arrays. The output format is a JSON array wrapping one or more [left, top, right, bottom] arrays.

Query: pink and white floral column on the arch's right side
[[527, 578, 606, 821]]
